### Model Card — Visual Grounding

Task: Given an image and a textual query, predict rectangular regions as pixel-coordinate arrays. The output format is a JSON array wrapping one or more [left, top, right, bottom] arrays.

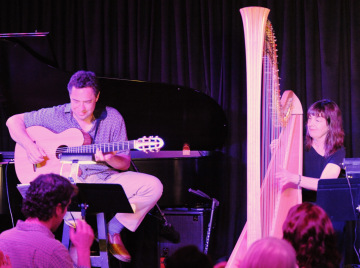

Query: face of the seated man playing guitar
[[70, 87, 99, 123]]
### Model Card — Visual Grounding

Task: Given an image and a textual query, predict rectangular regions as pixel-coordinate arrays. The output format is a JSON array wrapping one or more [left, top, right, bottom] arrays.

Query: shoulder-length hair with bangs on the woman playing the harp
[[305, 99, 345, 156]]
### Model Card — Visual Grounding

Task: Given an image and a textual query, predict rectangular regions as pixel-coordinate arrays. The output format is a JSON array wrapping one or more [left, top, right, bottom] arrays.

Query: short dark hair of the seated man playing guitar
[[67, 71, 100, 96]]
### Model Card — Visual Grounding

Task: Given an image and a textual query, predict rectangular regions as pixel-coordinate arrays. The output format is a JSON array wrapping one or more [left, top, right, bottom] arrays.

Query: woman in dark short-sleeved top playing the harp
[[276, 99, 345, 202]]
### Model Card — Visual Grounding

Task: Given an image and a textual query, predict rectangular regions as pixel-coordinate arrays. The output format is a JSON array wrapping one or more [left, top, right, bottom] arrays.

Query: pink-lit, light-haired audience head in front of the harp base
[[240, 237, 297, 268]]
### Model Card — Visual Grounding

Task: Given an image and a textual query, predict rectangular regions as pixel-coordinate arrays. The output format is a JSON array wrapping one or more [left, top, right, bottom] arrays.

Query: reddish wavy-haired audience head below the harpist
[[282, 202, 341, 268]]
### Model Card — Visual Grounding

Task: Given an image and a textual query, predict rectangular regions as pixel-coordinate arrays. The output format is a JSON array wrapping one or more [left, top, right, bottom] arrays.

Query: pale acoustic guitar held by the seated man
[[14, 126, 164, 183]]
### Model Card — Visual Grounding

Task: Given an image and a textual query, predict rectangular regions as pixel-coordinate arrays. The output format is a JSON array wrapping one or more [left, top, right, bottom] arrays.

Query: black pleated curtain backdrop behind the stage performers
[[0, 0, 360, 262]]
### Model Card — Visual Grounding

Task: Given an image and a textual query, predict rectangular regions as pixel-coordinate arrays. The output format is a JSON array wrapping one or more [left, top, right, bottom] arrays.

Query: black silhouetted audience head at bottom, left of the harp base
[[165, 245, 213, 268]]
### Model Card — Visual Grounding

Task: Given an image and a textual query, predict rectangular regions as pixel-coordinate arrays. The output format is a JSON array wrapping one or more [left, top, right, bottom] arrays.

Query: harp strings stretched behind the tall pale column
[[260, 21, 286, 237]]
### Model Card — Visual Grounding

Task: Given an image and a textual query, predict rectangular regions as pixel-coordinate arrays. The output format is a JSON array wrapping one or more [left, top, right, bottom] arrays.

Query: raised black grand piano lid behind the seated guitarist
[[0, 34, 227, 151]]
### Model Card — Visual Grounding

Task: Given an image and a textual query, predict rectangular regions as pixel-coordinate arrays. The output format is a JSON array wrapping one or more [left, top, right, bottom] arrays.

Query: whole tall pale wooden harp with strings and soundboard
[[226, 7, 303, 267]]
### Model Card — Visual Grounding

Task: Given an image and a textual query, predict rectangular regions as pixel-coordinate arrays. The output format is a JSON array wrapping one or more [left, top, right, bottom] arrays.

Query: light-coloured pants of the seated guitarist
[[64, 171, 163, 232]]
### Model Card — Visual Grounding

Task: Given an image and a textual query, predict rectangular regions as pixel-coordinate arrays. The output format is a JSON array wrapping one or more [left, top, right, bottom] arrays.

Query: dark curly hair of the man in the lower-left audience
[[21, 174, 78, 221]]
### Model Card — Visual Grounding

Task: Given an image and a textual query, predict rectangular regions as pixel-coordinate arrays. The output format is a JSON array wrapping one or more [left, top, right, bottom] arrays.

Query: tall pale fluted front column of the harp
[[240, 7, 270, 247]]
